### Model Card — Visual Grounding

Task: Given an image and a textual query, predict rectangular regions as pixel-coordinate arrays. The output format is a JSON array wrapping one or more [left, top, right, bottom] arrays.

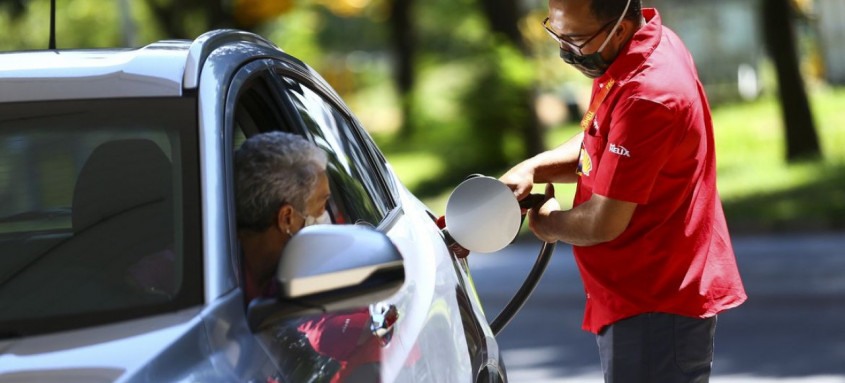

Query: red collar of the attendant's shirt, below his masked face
[[596, 8, 663, 83]]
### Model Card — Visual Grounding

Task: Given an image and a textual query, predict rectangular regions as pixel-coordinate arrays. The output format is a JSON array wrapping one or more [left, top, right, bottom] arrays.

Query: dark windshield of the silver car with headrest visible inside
[[0, 98, 203, 337]]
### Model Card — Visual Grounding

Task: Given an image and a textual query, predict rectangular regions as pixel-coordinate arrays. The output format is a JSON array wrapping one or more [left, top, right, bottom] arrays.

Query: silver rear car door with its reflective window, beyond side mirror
[[270, 68, 482, 382]]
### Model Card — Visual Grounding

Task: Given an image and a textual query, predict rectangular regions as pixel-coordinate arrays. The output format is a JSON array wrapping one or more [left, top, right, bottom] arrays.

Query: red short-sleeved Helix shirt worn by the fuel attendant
[[574, 9, 746, 333]]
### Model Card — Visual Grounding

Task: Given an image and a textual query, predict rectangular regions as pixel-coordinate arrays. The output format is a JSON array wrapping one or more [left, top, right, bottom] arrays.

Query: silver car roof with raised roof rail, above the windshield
[[0, 30, 278, 102]]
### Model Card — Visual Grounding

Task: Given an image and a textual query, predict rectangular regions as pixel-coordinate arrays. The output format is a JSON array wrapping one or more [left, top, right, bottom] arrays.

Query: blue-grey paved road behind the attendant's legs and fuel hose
[[470, 233, 845, 383]]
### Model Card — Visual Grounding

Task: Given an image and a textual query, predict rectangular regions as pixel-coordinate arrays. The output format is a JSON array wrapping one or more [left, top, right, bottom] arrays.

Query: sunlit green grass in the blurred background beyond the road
[[385, 88, 845, 233]]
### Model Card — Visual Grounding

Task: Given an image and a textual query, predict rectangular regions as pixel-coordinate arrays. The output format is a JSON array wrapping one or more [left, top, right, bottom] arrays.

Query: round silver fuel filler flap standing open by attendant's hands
[[446, 176, 522, 253]]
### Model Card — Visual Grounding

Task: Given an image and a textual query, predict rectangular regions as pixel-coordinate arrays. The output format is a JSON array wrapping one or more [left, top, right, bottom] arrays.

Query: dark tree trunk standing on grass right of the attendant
[[760, 0, 821, 162]]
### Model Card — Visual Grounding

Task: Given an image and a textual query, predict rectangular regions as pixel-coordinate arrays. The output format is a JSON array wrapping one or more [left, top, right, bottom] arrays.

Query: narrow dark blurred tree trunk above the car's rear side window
[[390, 0, 416, 138]]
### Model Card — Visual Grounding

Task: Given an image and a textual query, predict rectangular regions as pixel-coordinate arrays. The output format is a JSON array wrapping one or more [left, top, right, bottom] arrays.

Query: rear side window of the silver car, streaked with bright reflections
[[286, 80, 388, 225]]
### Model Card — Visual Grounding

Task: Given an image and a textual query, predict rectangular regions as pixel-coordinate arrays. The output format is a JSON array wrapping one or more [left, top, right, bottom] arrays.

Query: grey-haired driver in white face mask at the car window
[[235, 132, 331, 301]]
